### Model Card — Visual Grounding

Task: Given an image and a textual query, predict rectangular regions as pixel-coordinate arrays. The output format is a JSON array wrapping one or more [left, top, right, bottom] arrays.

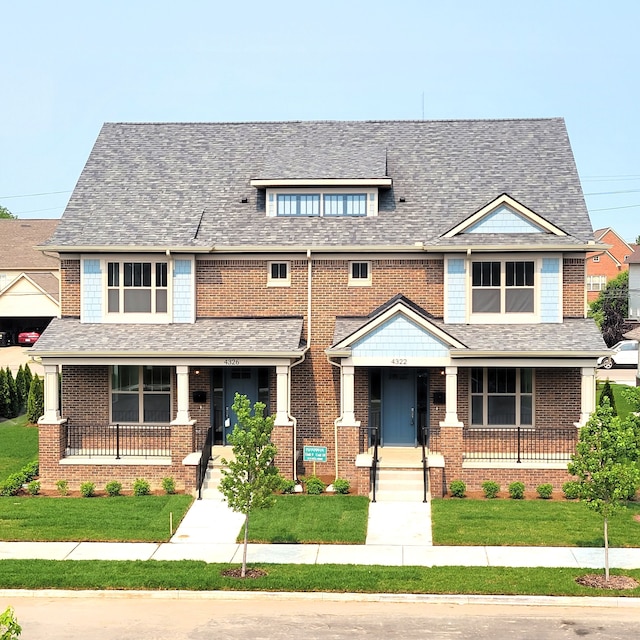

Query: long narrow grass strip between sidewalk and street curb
[[0, 560, 640, 598]]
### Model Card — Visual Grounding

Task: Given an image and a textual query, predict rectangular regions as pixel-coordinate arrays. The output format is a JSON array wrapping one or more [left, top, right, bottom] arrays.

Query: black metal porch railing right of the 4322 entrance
[[462, 427, 578, 463]]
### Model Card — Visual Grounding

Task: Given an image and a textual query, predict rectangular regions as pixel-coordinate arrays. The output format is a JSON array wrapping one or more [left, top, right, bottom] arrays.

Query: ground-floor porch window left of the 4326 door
[[111, 365, 171, 424]]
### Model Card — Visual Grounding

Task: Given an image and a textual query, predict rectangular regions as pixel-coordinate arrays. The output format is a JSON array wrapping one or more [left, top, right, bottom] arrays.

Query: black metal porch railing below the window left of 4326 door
[[66, 423, 171, 460]]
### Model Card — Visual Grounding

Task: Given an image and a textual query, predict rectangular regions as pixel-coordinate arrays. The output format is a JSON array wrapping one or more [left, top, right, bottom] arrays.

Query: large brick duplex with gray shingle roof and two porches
[[33, 119, 606, 495]]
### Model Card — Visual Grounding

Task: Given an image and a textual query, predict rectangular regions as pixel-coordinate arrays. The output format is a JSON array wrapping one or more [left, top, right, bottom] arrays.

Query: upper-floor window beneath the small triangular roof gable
[[471, 260, 535, 313]]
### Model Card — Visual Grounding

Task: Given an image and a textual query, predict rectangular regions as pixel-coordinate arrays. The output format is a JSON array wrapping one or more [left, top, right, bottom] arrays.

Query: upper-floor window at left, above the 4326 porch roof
[[107, 262, 168, 313]]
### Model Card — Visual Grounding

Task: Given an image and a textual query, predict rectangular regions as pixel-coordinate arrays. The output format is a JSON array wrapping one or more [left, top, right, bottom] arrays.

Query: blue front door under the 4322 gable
[[382, 369, 417, 447]]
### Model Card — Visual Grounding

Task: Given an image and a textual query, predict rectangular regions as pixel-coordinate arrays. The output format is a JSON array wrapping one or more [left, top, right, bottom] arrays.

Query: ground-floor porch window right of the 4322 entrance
[[471, 368, 533, 427]]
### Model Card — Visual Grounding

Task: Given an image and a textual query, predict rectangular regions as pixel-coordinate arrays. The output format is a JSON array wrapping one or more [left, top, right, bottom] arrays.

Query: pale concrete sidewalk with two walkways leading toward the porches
[[0, 500, 640, 569]]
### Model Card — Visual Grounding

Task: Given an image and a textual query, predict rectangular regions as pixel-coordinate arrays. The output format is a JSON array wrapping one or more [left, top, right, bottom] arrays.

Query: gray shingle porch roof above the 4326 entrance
[[31, 318, 302, 357]]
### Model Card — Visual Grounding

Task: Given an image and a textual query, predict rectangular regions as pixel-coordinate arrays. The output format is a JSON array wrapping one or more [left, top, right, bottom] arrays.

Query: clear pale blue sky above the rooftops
[[0, 0, 640, 241]]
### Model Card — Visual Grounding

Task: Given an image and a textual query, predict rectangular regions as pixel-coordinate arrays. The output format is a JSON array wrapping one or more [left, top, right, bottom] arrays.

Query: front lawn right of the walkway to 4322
[[431, 499, 640, 547]]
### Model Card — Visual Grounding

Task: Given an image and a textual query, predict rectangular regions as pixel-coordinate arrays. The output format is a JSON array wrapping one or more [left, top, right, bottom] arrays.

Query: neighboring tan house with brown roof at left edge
[[0, 219, 60, 343]]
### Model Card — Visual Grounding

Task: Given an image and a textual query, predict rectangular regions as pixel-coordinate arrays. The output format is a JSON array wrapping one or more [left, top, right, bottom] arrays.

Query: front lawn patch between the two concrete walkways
[[245, 495, 369, 544]]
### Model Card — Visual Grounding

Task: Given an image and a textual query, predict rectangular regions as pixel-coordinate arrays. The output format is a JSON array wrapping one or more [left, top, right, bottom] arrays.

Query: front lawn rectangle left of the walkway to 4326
[[0, 495, 193, 542]]
